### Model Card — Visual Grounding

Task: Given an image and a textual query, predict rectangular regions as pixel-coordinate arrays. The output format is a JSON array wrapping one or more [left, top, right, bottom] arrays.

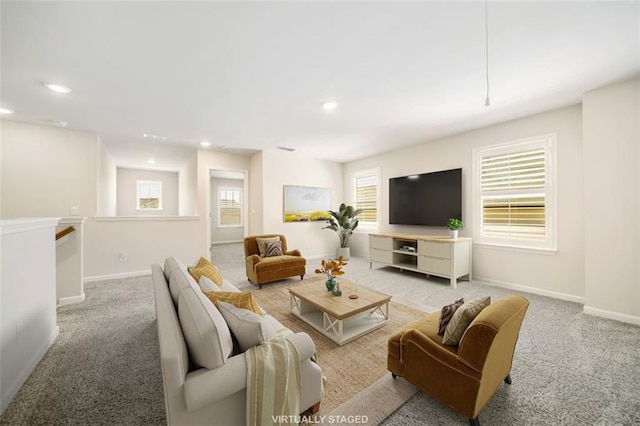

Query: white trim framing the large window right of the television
[[472, 133, 558, 253]]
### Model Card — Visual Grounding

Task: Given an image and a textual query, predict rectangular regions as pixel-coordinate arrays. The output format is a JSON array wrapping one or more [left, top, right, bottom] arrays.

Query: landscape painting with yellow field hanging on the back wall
[[283, 185, 331, 222]]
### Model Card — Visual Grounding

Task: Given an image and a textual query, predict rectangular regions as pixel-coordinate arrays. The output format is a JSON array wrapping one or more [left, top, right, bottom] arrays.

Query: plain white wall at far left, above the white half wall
[[0, 121, 98, 218]]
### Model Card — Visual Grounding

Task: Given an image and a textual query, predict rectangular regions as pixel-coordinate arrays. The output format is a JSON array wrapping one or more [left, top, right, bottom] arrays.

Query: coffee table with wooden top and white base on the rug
[[289, 278, 391, 345]]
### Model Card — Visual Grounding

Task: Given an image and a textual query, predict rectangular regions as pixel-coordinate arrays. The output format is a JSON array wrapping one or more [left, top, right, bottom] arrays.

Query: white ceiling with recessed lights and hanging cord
[[0, 1, 640, 169]]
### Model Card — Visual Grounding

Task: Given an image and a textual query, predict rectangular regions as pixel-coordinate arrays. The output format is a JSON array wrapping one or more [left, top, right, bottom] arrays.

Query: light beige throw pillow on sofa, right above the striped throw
[[218, 301, 276, 352]]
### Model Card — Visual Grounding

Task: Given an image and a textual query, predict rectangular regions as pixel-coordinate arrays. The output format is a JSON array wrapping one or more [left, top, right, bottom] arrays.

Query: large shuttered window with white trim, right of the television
[[474, 135, 556, 250]]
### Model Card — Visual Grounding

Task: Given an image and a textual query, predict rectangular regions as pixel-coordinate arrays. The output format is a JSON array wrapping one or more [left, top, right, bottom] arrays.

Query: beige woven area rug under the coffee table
[[253, 280, 424, 418]]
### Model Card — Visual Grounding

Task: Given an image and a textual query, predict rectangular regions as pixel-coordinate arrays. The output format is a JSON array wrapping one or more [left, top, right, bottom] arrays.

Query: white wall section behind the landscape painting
[[262, 150, 344, 259]]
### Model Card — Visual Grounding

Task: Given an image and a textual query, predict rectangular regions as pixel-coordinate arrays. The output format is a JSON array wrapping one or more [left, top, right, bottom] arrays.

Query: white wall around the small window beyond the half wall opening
[[116, 167, 178, 216]]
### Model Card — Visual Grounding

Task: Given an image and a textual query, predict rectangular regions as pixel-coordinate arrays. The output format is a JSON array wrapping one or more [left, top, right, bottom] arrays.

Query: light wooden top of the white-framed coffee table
[[289, 276, 391, 319]]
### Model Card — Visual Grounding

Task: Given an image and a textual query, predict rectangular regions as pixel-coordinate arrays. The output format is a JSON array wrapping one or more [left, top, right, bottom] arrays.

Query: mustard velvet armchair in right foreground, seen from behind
[[387, 296, 529, 426]]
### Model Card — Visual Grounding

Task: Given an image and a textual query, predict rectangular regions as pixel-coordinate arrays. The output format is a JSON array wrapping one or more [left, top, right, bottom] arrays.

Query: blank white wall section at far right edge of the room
[[583, 79, 640, 324]]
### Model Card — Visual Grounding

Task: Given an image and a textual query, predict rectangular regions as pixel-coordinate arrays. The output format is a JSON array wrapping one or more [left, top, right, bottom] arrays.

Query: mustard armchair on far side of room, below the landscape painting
[[244, 234, 307, 288]]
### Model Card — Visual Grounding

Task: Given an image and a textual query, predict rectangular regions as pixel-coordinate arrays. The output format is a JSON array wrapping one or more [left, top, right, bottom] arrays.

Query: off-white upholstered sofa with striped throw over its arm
[[151, 258, 322, 425]]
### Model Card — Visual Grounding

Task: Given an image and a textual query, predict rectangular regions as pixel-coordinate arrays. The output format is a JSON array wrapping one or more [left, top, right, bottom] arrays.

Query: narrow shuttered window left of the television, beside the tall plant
[[352, 169, 380, 231]]
